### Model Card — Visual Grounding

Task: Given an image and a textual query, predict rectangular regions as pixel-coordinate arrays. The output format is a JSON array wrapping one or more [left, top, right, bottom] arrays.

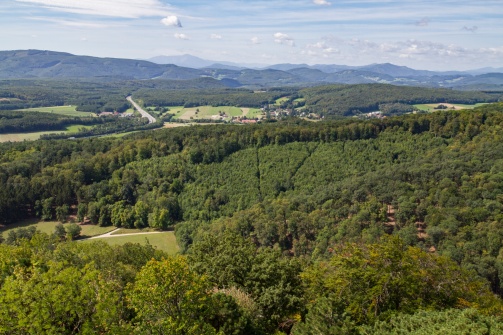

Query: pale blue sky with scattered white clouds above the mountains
[[0, 0, 503, 70]]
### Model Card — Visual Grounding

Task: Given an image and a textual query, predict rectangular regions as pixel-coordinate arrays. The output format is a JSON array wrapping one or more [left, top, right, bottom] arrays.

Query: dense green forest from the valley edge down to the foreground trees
[[0, 103, 503, 334]]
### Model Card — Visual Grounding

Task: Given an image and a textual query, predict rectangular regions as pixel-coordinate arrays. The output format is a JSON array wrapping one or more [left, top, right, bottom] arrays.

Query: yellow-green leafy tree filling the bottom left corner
[[0, 262, 118, 334]]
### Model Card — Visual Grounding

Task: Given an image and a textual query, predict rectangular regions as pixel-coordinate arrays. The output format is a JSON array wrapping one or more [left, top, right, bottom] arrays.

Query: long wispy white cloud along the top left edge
[[15, 0, 171, 18]]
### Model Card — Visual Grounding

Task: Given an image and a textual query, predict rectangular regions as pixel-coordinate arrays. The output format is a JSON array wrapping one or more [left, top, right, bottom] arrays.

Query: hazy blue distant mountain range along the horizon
[[0, 50, 503, 90]]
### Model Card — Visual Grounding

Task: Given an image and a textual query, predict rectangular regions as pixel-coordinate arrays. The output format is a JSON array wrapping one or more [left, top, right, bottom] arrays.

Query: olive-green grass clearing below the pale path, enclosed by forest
[[90, 232, 179, 255]]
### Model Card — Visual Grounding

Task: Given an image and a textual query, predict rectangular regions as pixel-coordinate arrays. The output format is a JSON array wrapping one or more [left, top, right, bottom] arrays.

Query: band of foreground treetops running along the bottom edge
[[0, 232, 503, 335]]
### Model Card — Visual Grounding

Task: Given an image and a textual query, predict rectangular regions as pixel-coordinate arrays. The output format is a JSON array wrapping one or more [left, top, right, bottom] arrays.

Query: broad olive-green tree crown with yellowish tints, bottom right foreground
[[297, 237, 502, 334]]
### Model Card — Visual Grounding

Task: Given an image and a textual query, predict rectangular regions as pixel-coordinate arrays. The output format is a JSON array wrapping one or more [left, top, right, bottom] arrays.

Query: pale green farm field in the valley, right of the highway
[[167, 106, 262, 121]]
